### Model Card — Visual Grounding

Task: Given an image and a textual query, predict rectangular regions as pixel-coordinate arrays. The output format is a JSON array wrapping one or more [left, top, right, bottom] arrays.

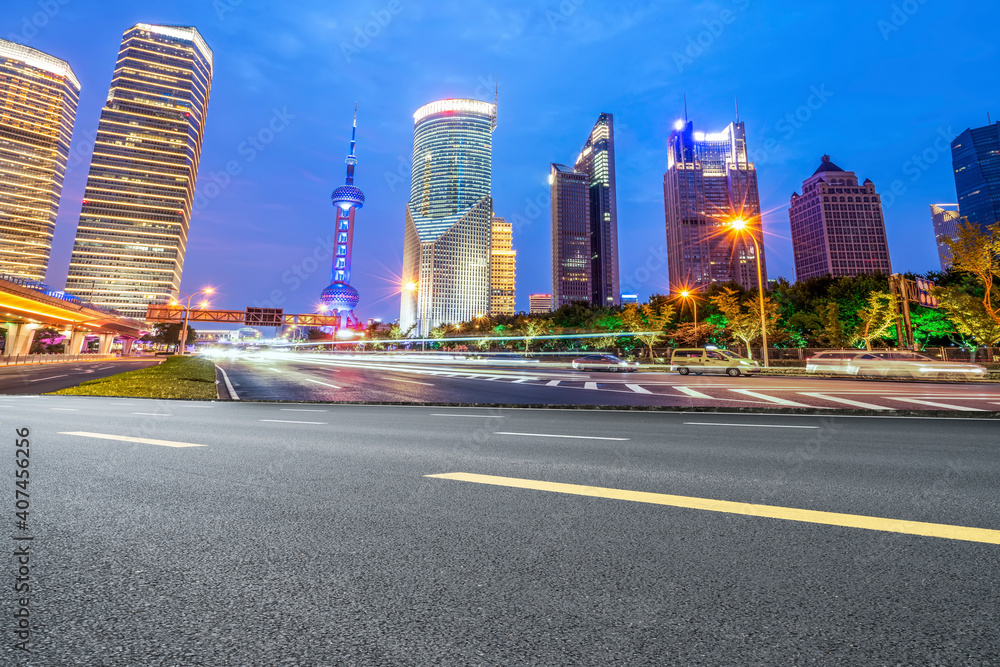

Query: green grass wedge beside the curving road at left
[[52, 357, 217, 399]]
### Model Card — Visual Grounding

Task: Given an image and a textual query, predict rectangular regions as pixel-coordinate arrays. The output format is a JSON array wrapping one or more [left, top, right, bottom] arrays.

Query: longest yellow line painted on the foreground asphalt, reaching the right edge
[[425, 472, 1000, 544]]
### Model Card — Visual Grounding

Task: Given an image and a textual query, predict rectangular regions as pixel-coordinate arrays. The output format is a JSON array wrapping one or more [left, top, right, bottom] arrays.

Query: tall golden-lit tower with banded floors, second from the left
[[66, 23, 212, 317]]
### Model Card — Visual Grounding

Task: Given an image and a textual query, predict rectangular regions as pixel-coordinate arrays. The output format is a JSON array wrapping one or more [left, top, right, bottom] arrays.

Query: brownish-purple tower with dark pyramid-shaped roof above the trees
[[788, 155, 892, 280]]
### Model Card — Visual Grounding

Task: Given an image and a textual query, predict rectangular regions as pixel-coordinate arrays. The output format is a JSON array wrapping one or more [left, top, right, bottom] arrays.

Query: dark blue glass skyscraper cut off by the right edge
[[951, 121, 1000, 227]]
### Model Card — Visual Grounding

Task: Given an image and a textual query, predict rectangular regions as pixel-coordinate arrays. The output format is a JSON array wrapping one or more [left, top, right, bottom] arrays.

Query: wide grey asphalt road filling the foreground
[[0, 396, 1000, 666]]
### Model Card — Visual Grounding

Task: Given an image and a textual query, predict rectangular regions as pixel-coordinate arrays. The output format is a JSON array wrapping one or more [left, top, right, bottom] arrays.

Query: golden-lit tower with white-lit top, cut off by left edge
[[0, 39, 80, 281]]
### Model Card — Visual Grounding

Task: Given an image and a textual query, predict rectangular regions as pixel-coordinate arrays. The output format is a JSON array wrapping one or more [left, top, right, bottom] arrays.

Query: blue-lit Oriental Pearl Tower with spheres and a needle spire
[[320, 103, 365, 328]]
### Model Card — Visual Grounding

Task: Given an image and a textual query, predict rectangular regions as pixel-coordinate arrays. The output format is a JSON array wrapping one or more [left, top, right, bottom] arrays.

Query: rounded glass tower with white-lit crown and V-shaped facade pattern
[[399, 99, 497, 336]]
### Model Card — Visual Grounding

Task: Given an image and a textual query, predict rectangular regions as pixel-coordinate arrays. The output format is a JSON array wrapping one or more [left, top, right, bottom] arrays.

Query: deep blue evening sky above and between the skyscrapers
[[0, 0, 1000, 320]]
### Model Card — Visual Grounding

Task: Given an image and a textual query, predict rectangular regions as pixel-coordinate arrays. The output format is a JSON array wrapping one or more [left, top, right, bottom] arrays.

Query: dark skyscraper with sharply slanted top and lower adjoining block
[[549, 113, 619, 308]]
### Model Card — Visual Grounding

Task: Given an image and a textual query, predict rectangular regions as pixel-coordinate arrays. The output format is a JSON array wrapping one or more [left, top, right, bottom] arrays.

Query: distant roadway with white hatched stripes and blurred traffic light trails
[[219, 353, 1000, 412]]
